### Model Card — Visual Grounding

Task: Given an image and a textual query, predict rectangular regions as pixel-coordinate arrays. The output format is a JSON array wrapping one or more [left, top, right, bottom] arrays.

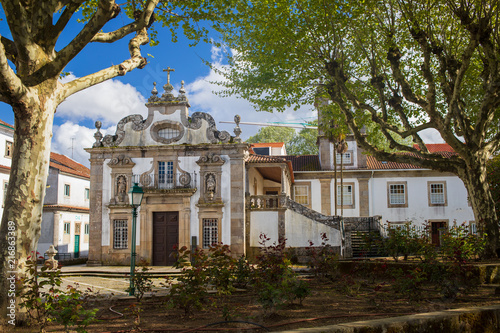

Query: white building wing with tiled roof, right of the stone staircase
[[285, 137, 475, 245]]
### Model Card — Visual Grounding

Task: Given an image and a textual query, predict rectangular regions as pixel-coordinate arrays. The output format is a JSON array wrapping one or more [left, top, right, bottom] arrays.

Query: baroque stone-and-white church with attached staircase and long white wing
[[87, 72, 473, 266]]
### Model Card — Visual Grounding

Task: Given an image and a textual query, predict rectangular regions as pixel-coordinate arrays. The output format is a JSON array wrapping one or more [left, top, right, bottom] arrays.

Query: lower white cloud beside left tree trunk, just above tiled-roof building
[[51, 121, 116, 167]]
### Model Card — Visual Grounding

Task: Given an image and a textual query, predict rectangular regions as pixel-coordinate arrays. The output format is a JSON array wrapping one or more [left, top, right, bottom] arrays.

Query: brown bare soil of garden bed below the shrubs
[[23, 268, 500, 332]]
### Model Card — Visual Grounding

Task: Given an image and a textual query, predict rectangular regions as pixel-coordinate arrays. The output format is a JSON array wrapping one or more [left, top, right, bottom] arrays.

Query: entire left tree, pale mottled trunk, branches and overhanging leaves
[[0, 0, 233, 320]]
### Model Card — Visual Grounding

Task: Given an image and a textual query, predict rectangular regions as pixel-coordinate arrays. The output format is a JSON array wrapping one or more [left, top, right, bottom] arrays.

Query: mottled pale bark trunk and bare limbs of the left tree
[[0, 0, 159, 322]]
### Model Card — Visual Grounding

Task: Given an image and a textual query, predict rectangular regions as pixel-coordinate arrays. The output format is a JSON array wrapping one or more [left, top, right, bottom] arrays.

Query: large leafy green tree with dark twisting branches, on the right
[[211, 0, 500, 256]]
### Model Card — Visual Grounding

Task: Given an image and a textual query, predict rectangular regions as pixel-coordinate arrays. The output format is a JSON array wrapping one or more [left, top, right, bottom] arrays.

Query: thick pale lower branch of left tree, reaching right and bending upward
[[58, 28, 149, 102]]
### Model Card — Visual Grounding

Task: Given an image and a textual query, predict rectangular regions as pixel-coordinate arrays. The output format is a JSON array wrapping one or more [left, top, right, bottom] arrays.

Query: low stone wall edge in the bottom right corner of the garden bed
[[281, 305, 500, 333]]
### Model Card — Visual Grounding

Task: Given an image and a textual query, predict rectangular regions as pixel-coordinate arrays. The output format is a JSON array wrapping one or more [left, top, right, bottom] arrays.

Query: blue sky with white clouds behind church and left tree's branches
[[0, 8, 446, 166]]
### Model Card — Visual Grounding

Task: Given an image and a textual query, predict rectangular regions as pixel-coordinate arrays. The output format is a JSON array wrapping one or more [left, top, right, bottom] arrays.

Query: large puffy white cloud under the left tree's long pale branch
[[56, 74, 147, 126]]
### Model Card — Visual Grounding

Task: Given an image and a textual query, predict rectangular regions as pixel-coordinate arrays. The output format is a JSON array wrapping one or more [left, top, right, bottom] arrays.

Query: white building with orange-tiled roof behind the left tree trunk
[[0, 120, 90, 259]]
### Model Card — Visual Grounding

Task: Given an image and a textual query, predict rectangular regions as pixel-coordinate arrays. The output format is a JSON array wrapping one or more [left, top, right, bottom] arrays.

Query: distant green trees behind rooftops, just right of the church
[[246, 126, 318, 155]]
